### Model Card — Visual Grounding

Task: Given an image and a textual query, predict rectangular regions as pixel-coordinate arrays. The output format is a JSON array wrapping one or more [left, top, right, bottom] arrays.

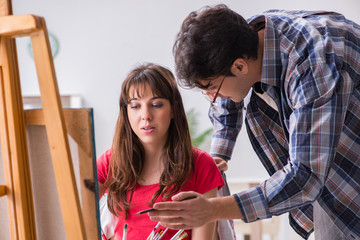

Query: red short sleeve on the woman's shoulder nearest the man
[[194, 150, 224, 194]]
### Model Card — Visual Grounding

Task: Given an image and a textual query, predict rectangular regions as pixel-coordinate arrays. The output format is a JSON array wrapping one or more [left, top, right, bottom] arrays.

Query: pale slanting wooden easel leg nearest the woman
[[31, 18, 86, 239]]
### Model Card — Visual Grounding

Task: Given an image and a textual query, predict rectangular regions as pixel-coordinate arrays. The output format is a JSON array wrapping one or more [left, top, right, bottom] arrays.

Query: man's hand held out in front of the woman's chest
[[149, 192, 215, 229]]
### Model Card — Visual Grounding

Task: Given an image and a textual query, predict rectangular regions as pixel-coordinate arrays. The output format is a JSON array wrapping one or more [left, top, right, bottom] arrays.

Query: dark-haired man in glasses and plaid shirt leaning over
[[149, 5, 360, 240]]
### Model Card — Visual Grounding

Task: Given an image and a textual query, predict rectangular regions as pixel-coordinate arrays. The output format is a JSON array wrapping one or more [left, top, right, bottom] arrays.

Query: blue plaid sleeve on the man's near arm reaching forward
[[234, 29, 354, 222]]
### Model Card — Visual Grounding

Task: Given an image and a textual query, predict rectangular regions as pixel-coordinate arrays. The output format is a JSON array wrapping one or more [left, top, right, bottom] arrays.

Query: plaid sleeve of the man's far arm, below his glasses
[[209, 99, 244, 160]]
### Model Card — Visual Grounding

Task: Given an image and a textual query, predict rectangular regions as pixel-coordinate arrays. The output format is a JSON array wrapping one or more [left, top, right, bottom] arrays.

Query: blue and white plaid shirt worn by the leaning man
[[209, 10, 360, 239]]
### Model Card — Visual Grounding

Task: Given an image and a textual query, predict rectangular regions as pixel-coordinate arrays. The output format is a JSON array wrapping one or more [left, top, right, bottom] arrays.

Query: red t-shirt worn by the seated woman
[[96, 148, 224, 240]]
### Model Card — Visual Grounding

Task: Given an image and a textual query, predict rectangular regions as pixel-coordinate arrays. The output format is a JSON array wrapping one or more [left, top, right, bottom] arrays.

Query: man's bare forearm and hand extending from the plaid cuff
[[149, 192, 242, 229]]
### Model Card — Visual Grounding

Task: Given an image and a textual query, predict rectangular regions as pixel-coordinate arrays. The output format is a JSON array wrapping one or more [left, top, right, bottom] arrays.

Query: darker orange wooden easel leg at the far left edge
[[0, 36, 36, 239]]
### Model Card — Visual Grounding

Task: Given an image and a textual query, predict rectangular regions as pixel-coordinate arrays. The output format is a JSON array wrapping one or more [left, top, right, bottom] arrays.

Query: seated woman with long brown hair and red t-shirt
[[97, 64, 223, 240]]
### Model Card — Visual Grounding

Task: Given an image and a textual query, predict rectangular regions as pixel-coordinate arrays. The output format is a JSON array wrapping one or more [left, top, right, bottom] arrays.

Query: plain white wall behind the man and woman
[[13, 0, 360, 180]]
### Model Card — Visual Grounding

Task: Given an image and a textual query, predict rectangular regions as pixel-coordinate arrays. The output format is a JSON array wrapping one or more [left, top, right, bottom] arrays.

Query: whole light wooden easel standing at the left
[[0, 0, 87, 240]]
